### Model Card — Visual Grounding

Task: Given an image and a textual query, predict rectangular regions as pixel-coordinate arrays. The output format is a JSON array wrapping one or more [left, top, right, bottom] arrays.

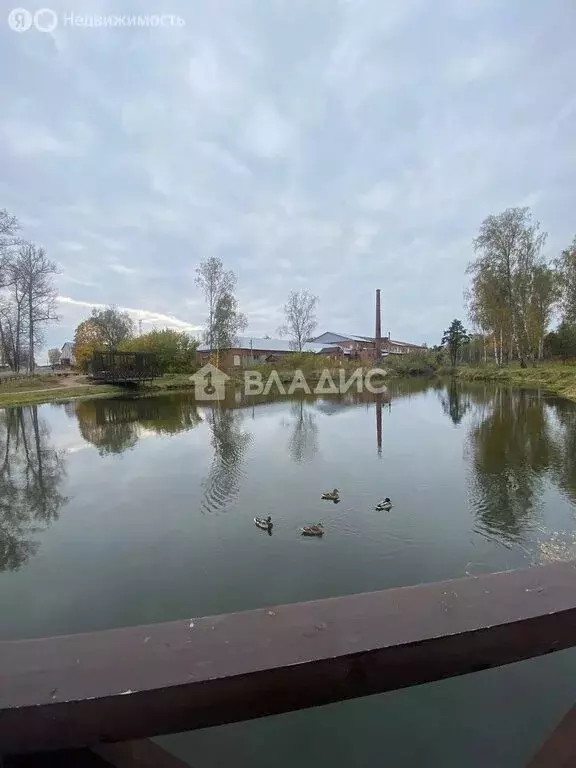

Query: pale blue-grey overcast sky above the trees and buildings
[[0, 0, 576, 354]]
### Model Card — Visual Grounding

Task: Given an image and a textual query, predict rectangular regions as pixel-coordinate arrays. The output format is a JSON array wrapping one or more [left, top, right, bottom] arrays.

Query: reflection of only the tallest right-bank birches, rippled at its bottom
[[470, 388, 553, 539]]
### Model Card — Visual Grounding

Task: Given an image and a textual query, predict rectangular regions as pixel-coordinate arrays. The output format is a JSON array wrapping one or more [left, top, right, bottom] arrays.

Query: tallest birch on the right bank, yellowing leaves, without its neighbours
[[468, 208, 546, 363]]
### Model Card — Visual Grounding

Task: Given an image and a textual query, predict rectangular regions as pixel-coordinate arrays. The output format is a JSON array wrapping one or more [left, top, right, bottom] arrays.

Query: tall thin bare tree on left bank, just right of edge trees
[[15, 242, 58, 373]]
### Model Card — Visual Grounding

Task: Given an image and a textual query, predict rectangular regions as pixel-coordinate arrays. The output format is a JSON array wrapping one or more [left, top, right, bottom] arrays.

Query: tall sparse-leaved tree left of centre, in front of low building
[[196, 256, 248, 350]]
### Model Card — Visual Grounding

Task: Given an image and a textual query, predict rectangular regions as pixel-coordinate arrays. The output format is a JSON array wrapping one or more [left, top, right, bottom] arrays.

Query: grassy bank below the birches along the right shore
[[456, 363, 576, 400]]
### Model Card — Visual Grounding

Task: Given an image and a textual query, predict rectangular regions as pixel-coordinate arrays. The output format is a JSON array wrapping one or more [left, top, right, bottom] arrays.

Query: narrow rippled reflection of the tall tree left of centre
[[202, 406, 252, 512]]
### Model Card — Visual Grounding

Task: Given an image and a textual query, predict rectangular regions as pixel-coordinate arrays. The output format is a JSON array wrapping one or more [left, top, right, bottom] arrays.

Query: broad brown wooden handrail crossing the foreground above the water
[[0, 563, 576, 753]]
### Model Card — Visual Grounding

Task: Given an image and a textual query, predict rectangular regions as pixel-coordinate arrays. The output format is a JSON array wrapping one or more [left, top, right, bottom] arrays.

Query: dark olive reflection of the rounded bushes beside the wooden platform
[[76, 395, 201, 456]]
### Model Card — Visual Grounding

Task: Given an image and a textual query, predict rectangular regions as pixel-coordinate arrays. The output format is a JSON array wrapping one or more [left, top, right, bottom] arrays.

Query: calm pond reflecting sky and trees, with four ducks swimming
[[0, 380, 576, 768]]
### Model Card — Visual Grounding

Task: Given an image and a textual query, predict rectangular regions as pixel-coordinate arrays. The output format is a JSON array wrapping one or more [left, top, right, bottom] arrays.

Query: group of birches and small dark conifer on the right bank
[[442, 208, 576, 366]]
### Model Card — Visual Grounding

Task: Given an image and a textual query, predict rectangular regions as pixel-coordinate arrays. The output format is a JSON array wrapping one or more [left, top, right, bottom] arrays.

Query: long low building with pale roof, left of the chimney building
[[198, 336, 330, 368]]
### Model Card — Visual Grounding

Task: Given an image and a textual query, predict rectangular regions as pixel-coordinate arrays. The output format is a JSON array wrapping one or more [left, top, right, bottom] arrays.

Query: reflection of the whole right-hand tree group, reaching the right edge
[[468, 387, 574, 542]]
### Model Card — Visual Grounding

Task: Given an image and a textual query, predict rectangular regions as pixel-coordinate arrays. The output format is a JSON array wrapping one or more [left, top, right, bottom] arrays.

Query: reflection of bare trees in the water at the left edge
[[0, 405, 66, 571]]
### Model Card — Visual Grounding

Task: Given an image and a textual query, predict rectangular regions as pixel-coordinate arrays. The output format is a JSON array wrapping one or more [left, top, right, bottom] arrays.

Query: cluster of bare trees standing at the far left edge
[[0, 210, 58, 373]]
